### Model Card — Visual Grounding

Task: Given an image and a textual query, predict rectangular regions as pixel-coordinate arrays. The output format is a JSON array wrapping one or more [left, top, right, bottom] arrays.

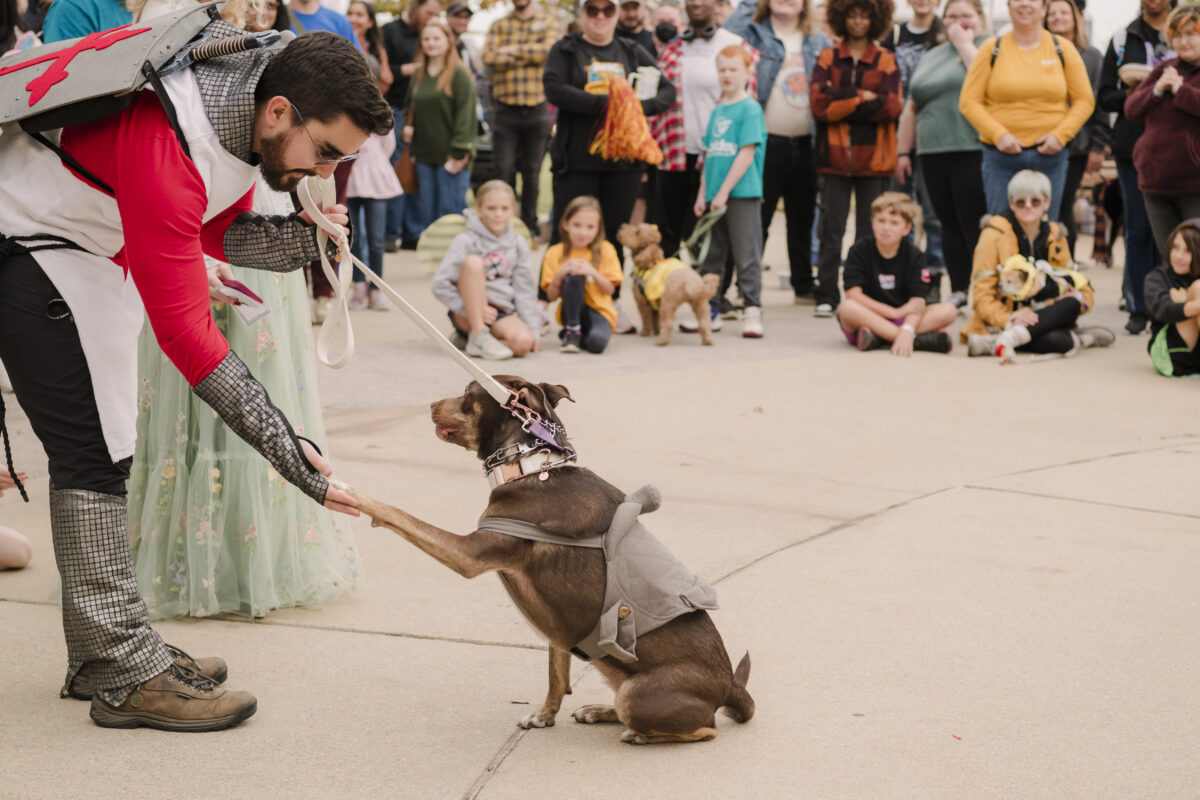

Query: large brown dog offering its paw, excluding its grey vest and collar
[[355, 375, 755, 745]]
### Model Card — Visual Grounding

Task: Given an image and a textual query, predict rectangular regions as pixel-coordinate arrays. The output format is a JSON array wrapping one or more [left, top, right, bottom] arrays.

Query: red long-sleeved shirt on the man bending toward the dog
[[61, 91, 254, 386]]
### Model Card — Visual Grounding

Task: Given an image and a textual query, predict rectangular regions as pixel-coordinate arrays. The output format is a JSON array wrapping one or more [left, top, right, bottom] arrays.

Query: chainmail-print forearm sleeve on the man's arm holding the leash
[[224, 211, 337, 272]]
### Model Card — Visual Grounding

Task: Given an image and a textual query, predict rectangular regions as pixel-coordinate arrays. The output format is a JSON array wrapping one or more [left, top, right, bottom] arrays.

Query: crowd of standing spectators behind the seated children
[[2, 0, 1200, 362]]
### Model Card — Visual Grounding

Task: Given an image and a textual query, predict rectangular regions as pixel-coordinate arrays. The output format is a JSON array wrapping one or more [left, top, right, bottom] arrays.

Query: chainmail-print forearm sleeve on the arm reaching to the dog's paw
[[192, 350, 329, 504]]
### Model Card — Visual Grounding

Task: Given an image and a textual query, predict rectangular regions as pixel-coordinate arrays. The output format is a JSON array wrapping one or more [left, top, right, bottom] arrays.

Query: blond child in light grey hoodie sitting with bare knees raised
[[433, 180, 541, 361]]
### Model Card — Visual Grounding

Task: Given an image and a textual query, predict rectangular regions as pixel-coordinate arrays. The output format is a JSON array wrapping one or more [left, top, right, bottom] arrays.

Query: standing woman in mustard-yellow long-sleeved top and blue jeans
[[959, 0, 1096, 219]]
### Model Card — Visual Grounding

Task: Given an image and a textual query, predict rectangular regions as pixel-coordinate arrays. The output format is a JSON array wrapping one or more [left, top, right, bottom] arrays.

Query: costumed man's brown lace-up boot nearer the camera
[[91, 661, 258, 732]]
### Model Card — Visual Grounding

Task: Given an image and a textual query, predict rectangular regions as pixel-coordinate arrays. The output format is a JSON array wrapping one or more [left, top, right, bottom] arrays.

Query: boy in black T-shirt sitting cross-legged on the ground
[[838, 192, 958, 355]]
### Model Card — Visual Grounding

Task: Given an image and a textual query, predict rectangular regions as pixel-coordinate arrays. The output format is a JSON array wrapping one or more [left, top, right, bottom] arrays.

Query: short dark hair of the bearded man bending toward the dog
[[254, 31, 392, 133]]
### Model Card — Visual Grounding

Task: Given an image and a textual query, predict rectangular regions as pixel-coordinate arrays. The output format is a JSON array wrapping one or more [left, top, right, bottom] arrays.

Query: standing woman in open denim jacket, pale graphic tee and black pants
[[725, 0, 830, 297]]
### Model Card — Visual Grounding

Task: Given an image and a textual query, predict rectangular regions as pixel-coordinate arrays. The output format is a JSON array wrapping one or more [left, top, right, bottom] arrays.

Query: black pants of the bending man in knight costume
[[0, 253, 132, 497]]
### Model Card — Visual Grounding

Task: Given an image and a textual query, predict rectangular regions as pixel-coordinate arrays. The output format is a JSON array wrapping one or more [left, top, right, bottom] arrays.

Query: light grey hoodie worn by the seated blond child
[[433, 210, 541, 337]]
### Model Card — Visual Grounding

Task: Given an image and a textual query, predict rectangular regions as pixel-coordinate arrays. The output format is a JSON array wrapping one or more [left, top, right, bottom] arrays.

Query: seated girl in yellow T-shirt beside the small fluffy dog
[[541, 194, 622, 353]]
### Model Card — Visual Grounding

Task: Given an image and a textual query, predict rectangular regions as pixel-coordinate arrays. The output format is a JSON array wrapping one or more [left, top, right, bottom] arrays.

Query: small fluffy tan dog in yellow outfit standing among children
[[617, 222, 721, 347]]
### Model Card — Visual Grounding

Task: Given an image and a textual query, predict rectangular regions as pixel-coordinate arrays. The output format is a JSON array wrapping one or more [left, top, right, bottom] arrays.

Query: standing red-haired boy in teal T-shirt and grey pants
[[694, 44, 767, 339]]
